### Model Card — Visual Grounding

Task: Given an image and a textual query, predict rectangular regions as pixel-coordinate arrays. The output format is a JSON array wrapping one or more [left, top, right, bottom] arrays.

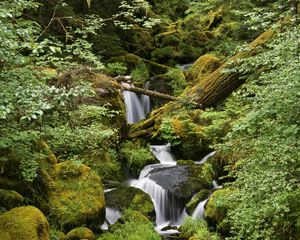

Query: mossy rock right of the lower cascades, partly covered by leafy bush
[[204, 188, 233, 234]]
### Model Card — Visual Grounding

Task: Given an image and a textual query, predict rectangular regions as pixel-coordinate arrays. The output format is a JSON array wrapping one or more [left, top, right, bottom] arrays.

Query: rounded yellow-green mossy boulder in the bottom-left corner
[[0, 206, 49, 240]]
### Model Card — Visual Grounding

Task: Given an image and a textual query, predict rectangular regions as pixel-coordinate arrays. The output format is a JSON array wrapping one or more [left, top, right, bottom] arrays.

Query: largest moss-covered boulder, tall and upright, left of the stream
[[48, 161, 105, 230]]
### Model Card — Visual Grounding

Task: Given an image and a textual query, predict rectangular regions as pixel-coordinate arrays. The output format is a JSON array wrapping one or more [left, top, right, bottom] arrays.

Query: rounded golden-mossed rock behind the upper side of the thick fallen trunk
[[188, 54, 220, 81]]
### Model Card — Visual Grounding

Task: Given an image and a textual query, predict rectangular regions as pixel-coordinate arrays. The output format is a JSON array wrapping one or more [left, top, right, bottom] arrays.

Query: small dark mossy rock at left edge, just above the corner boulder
[[0, 189, 24, 210]]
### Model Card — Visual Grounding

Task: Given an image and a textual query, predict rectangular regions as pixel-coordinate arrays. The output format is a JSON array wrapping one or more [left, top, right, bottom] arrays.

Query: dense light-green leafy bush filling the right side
[[218, 26, 300, 239]]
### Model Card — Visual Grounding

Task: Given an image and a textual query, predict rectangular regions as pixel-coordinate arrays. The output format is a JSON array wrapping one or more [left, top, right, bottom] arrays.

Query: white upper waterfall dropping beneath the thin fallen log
[[122, 83, 151, 123]]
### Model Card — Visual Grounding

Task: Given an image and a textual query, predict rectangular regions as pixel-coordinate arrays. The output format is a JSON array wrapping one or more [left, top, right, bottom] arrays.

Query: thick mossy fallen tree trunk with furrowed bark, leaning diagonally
[[128, 29, 275, 138]]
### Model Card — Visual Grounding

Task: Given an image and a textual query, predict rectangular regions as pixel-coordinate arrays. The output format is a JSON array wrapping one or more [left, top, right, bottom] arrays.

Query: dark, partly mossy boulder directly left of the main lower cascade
[[105, 186, 154, 217]]
